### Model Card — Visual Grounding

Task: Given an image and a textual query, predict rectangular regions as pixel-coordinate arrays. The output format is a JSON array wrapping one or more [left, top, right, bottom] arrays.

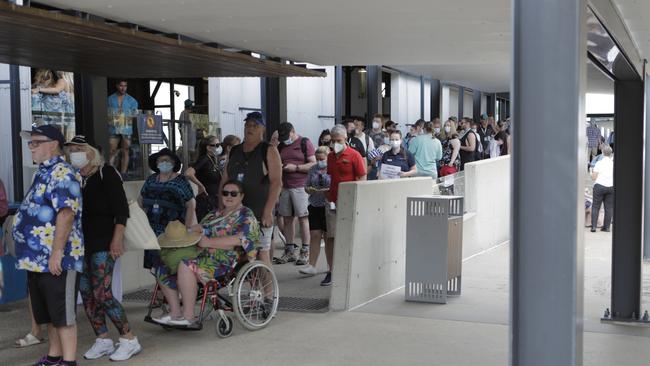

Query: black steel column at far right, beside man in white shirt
[[611, 80, 645, 320]]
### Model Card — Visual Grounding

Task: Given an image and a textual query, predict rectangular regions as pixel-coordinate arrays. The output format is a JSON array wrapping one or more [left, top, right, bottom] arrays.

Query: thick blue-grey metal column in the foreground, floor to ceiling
[[510, 0, 587, 366]]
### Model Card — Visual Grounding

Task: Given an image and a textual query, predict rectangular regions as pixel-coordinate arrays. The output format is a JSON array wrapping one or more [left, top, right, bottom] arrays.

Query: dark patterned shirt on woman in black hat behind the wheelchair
[[140, 174, 194, 235]]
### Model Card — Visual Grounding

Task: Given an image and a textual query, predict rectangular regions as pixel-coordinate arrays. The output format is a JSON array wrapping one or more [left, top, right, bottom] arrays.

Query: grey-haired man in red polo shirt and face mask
[[320, 125, 366, 286]]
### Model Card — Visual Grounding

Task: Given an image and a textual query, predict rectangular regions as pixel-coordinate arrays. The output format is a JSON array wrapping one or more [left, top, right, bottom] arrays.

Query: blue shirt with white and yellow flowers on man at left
[[12, 156, 84, 273]]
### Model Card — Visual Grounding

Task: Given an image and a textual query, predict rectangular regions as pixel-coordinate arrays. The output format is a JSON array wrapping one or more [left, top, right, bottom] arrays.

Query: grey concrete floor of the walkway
[[0, 227, 650, 366]]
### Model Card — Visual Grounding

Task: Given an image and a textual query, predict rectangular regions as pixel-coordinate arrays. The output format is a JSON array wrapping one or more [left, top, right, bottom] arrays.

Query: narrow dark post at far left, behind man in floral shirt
[[9, 65, 23, 202]]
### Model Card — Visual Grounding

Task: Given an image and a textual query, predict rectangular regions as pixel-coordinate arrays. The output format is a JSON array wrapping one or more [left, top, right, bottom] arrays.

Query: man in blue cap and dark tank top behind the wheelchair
[[220, 112, 282, 267]]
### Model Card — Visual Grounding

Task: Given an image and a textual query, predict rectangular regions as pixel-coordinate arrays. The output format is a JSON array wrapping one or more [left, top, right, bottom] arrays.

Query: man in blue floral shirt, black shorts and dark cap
[[13, 125, 84, 366]]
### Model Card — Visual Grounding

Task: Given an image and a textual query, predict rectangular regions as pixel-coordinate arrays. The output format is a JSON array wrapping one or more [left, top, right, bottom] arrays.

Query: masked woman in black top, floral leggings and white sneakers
[[66, 136, 142, 361]]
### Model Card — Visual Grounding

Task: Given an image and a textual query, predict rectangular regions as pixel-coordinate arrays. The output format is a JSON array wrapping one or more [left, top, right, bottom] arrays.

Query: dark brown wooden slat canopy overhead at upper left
[[0, 1, 326, 78]]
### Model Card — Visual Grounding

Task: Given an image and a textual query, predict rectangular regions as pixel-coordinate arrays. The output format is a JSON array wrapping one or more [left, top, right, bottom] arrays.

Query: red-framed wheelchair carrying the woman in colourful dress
[[144, 261, 280, 338]]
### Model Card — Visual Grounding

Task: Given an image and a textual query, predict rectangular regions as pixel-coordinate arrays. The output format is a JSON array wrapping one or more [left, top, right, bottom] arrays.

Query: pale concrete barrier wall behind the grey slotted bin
[[330, 156, 510, 310]]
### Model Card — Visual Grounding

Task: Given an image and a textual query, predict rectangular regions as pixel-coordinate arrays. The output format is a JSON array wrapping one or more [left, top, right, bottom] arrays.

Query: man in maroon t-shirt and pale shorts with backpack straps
[[278, 122, 316, 265]]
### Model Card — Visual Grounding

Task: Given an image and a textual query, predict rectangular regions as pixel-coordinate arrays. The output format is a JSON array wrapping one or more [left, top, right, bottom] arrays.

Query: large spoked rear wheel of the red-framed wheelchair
[[232, 261, 280, 330]]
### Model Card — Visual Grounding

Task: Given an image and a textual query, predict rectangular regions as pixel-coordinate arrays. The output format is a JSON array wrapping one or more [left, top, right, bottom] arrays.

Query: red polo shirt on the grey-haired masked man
[[327, 146, 366, 202]]
